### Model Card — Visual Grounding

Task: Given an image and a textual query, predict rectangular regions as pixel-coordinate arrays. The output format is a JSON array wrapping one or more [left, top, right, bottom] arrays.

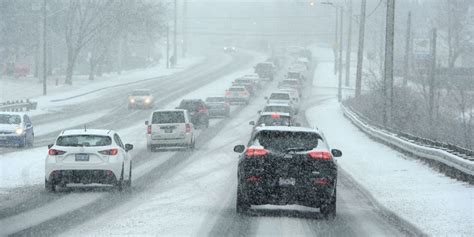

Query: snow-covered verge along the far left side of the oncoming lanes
[[0, 57, 204, 116]]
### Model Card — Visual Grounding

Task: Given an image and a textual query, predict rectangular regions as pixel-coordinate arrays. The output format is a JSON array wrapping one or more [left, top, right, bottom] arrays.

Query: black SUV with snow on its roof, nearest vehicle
[[234, 127, 342, 218]]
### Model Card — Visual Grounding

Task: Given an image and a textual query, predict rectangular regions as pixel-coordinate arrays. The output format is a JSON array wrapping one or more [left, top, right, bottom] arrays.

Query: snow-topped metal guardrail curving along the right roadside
[[341, 102, 474, 183]]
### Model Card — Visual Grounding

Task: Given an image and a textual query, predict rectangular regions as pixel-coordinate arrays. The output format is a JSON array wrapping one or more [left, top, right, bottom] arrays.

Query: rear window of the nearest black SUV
[[254, 131, 321, 152]]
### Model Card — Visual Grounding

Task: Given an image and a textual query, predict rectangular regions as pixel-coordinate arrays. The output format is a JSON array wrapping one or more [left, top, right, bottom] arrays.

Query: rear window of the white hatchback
[[56, 135, 112, 147]]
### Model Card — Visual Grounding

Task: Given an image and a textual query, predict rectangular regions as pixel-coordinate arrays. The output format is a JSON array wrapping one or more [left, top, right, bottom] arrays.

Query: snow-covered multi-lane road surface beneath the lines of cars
[[0, 47, 468, 236]]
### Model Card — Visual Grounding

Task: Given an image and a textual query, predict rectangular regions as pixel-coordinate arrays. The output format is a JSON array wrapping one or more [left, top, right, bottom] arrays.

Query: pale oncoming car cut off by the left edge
[[0, 112, 35, 147]]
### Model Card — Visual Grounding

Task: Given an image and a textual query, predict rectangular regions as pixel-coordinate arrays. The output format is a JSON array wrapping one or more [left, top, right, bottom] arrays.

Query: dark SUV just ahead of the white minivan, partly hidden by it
[[176, 99, 209, 128]]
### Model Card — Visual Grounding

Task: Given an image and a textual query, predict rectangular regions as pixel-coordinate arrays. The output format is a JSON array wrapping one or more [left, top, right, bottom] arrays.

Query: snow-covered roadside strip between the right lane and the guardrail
[[306, 45, 474, 236]]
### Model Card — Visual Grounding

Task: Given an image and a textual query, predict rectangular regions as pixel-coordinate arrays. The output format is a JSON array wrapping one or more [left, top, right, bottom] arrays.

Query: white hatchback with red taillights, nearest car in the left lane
[[45, 128, 133, 192]]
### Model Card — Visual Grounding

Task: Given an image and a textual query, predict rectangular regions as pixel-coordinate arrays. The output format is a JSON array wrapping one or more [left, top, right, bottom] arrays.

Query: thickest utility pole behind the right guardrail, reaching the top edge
[[383, 0, 395, 126]]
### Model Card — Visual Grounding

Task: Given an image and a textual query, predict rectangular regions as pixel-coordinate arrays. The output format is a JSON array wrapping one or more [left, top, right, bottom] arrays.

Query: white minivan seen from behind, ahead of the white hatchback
[[145, 109, 195, 151]]
